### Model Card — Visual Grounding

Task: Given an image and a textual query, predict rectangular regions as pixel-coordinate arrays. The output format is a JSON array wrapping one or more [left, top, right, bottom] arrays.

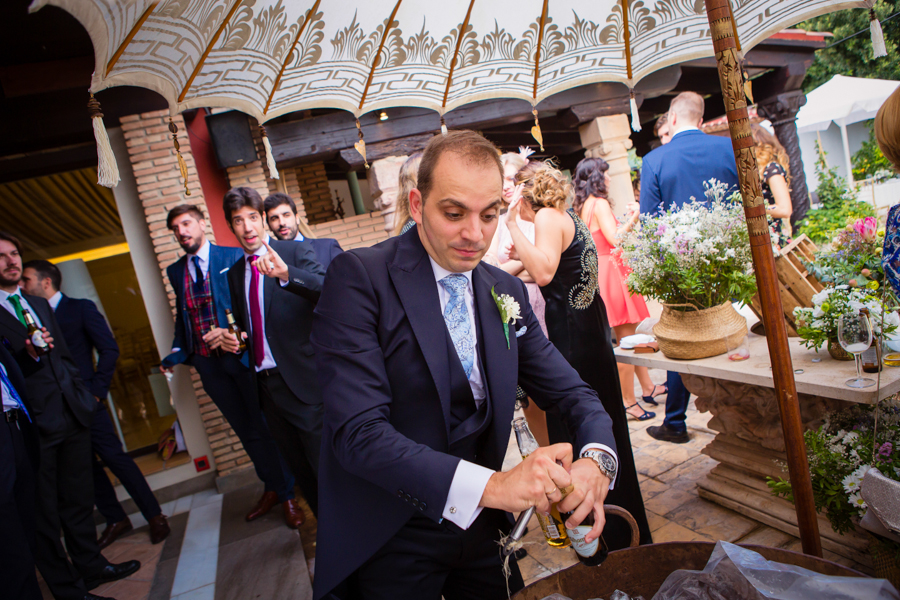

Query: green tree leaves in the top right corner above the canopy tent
[[797, 0, 900, 92]]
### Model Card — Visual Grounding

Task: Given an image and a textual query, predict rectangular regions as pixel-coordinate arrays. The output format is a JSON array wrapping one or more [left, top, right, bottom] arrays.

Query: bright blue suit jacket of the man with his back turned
[[640, 130, 739, 214]]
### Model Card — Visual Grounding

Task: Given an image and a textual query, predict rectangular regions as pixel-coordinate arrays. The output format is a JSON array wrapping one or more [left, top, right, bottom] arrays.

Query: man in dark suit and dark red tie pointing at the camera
[[214, 187, 325, 515]]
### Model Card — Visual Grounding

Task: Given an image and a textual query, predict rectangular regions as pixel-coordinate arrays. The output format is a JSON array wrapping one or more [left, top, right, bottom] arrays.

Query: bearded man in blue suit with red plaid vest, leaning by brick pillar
[[162, 204, 304, 529]]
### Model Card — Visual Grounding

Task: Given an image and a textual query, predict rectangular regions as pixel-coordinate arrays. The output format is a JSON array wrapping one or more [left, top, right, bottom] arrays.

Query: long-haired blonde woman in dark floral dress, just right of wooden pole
[[750, 123, 794, 246]]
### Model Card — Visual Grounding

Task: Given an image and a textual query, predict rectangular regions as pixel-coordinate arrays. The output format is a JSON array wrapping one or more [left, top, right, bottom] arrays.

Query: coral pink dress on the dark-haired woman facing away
[[588, 200, 650, 327]]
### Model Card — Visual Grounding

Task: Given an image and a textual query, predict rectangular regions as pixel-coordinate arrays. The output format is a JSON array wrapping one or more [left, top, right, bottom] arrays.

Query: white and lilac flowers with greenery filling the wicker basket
[[618, 179, 756, 309]]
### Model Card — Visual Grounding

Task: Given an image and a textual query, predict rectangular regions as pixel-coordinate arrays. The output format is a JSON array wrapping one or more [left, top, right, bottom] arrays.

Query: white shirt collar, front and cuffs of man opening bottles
[[436, 256, 619, 529]]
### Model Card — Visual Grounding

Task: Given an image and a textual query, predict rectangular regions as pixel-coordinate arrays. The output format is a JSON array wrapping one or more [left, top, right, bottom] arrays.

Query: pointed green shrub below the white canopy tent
[[798, 141, 875, 244]]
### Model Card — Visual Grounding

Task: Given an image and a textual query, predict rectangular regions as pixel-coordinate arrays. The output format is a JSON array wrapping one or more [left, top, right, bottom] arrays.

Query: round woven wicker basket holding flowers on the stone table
[[653, 302, 747, 360]]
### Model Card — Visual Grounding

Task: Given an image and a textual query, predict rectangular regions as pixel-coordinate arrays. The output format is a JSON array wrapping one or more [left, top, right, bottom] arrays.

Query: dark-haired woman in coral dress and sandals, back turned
[[572, 158, 666, 421]]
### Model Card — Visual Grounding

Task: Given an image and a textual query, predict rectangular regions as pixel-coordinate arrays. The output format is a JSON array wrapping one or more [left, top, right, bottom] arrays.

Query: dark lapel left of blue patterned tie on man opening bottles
[[389, 234, 450, 438]]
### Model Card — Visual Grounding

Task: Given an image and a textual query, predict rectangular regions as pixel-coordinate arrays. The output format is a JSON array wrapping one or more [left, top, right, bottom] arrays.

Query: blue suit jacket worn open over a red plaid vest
[[162, 241, 247, 367]]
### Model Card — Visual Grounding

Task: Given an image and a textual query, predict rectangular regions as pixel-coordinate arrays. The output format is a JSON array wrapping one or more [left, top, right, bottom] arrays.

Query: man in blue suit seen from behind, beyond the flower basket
[[641, 92, 738, 444]]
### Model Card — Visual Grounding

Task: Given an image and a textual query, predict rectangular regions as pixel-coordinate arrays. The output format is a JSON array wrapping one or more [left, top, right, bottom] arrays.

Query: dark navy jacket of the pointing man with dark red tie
[[228, 239, 325, 404]]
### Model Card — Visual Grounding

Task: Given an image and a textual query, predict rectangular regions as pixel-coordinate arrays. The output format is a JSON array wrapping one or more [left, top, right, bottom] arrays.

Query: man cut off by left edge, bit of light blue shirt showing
[[0, 336, 43, 600]]
